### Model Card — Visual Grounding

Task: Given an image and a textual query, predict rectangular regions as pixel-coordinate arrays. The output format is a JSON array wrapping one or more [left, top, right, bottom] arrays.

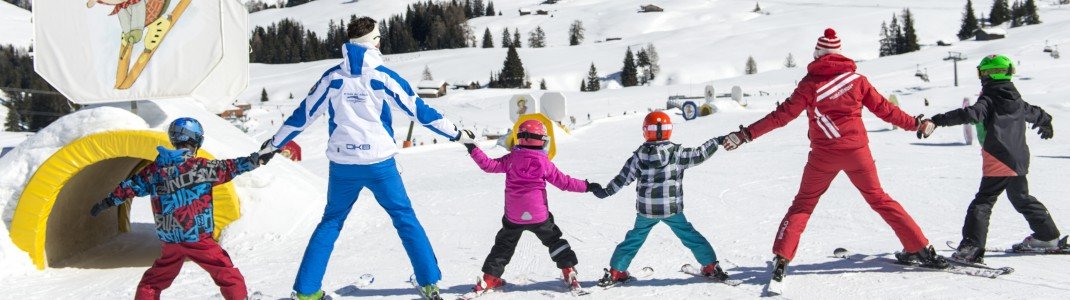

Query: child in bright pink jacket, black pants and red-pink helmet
[[461, 120, 601, 294]]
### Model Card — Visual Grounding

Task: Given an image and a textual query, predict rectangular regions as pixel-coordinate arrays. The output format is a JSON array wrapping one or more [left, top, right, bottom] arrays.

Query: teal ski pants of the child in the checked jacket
[[609, 212, 717, 271]]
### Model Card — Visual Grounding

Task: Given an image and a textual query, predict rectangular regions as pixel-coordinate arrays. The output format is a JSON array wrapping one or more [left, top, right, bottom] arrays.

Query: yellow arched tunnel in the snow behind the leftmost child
[[11, 131, 241, 270]]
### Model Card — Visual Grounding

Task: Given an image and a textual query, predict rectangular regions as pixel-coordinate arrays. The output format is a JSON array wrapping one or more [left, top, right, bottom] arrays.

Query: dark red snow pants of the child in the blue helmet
[[134, 236, 248, 300]]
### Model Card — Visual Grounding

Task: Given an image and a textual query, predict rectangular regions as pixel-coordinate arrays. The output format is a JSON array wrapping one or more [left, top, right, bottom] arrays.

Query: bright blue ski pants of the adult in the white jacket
[[293, 159, 442, 295]]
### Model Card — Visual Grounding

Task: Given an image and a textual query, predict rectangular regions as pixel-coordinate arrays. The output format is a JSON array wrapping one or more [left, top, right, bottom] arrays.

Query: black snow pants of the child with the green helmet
[[962, 176, 1059, 249]]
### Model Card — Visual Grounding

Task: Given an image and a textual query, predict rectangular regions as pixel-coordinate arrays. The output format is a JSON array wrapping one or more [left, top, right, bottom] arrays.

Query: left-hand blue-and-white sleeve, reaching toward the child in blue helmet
[[272, 66, 342, 149]]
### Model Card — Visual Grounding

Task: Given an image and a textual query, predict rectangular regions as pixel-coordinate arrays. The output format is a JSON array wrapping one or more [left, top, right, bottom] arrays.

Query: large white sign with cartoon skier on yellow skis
[[33, 0, 248, 110]]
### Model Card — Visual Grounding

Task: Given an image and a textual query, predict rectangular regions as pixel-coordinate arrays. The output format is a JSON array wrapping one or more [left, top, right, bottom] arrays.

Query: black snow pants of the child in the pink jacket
[[483, 214, 578, 278]]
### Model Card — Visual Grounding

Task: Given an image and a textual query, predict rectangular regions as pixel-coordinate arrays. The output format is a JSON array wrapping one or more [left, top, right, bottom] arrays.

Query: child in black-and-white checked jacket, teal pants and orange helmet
[[592, 111, 729, 286]]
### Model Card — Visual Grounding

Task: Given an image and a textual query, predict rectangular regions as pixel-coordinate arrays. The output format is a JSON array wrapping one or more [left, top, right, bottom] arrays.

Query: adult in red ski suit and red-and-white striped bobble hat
[[722, 29, 947, 272]]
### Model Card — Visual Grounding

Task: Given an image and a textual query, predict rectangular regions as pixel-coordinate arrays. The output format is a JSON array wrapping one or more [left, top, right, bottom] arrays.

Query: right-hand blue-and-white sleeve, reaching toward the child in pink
[[371, 65, 460, 140]]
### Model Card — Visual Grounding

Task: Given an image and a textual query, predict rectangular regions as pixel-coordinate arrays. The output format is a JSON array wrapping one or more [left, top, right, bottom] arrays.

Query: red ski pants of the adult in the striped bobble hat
[[773, 146, 929, 260]]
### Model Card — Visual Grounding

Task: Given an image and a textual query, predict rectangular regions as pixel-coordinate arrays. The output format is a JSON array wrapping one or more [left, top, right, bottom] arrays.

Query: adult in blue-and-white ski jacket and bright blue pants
[[262, 17, 473, 299]]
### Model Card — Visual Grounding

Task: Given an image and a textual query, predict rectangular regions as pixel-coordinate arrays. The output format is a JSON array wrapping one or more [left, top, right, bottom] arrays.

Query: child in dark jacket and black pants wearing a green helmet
[[921, 55, 1059, 263]]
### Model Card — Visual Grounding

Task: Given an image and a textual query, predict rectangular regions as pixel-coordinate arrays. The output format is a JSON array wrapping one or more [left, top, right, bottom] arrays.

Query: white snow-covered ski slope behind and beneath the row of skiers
[[6, 0, 1070, 299]]
